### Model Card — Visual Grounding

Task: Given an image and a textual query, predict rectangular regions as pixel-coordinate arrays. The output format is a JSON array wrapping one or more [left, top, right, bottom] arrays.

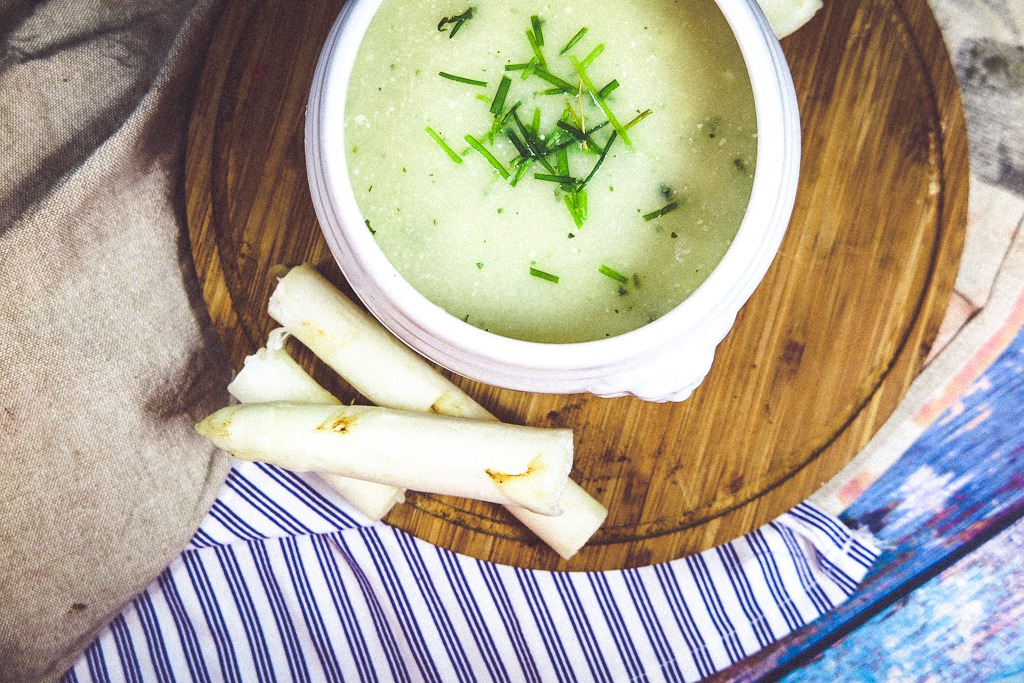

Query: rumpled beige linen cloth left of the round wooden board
[[0, 0, 229, 682]]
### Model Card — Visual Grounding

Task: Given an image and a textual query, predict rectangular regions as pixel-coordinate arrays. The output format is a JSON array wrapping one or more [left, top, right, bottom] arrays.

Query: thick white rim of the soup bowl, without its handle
[[306, 0, 800, 375]]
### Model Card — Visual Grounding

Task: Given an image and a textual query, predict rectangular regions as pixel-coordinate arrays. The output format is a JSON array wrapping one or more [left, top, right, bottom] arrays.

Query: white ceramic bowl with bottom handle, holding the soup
[[306, 0, 800, 401]]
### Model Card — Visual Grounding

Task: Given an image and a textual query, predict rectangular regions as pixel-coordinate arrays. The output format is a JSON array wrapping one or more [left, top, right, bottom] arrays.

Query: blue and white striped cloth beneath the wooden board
[[65, 463, 878, 682]]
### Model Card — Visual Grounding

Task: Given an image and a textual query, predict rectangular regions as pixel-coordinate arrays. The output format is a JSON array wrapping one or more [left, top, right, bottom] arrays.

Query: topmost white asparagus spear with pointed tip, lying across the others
[[196, 402, 572, 515]]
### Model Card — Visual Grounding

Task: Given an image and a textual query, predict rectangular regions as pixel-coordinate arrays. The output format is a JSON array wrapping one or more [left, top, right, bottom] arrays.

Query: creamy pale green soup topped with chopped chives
[[344, 0, 757, 342]]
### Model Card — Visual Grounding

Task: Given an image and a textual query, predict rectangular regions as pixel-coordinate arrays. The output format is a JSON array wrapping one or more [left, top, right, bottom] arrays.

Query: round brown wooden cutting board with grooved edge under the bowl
[[186, 0, 968, 570]]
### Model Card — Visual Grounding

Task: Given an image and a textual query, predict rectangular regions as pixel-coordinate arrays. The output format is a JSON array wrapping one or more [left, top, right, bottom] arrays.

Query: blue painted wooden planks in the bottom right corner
[[718, 323, 1024, 683]]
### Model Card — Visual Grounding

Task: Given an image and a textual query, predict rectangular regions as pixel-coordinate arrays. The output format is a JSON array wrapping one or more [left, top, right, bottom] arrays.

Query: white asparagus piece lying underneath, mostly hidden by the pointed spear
[[227, 328, 406, 521]]
